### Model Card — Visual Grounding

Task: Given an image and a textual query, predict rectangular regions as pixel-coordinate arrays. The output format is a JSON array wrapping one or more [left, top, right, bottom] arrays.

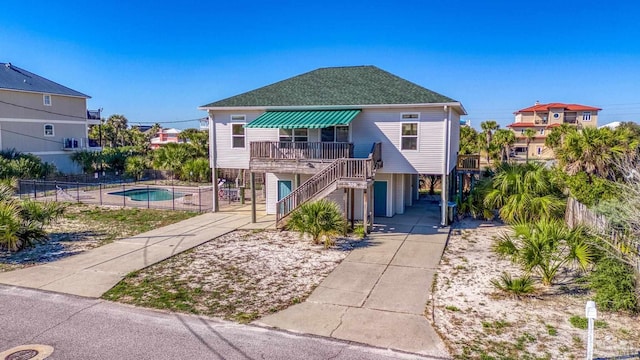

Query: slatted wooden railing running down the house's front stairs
[[276, 143, 382, 224]]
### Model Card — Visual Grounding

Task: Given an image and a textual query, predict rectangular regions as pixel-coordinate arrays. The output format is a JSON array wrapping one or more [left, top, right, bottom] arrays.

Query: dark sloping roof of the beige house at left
[[0, 63, 90, 98]]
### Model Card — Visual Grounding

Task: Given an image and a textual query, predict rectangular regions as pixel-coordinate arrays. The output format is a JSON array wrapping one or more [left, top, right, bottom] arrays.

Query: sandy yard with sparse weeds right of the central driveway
[[427, 219, 640, 359]]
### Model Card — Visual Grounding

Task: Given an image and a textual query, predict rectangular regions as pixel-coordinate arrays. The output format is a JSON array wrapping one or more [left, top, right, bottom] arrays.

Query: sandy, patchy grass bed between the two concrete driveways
[[103, 230, 356, 322]]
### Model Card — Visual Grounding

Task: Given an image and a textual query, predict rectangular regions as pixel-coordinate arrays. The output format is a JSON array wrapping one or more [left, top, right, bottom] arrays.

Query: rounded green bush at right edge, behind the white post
[[588, 257, 640, 312]]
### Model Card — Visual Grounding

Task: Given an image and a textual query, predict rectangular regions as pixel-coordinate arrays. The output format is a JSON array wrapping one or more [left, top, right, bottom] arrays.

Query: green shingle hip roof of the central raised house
[[202, 66, 456, 107]]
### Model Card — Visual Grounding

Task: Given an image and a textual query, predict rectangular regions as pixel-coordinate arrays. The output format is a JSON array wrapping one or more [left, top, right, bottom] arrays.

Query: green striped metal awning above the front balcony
[[245, 110, 361, 129]]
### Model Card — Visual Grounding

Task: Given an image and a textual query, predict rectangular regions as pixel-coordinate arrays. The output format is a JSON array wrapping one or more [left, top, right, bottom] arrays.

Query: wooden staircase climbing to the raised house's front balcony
[[276, 143, 383, 227]]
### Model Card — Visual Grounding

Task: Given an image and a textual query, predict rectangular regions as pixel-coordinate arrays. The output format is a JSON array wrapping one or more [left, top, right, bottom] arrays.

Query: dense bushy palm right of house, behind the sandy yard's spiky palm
[[484, 163, 565, 223]]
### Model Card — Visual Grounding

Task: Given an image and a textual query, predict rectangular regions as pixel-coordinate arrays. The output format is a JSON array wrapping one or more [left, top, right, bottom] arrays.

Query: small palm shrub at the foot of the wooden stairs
[[287, 199, 346, 248]]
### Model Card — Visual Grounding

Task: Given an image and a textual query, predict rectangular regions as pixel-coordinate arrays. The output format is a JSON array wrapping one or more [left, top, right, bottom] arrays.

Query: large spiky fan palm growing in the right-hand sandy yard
[[494, 219, 596, 286]]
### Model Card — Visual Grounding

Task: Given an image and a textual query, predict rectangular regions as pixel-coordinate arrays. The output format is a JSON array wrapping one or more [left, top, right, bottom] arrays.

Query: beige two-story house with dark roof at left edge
[[0, 63, 100, 173]]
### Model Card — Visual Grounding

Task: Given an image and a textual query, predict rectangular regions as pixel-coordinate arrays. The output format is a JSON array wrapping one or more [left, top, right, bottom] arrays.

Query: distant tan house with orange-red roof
[[507, 102, 602, 159]]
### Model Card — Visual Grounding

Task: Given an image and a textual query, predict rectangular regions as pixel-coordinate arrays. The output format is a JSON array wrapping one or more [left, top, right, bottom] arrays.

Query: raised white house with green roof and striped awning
[[200, 66, 466, 228]]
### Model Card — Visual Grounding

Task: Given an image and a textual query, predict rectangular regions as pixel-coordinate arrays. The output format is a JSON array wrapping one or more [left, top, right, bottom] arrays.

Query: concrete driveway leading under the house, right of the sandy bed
[[256, 202, 449, 359]]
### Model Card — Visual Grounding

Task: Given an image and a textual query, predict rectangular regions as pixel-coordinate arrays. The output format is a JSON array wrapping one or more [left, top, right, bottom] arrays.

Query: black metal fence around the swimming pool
[[18, 180, 225, 212]]
